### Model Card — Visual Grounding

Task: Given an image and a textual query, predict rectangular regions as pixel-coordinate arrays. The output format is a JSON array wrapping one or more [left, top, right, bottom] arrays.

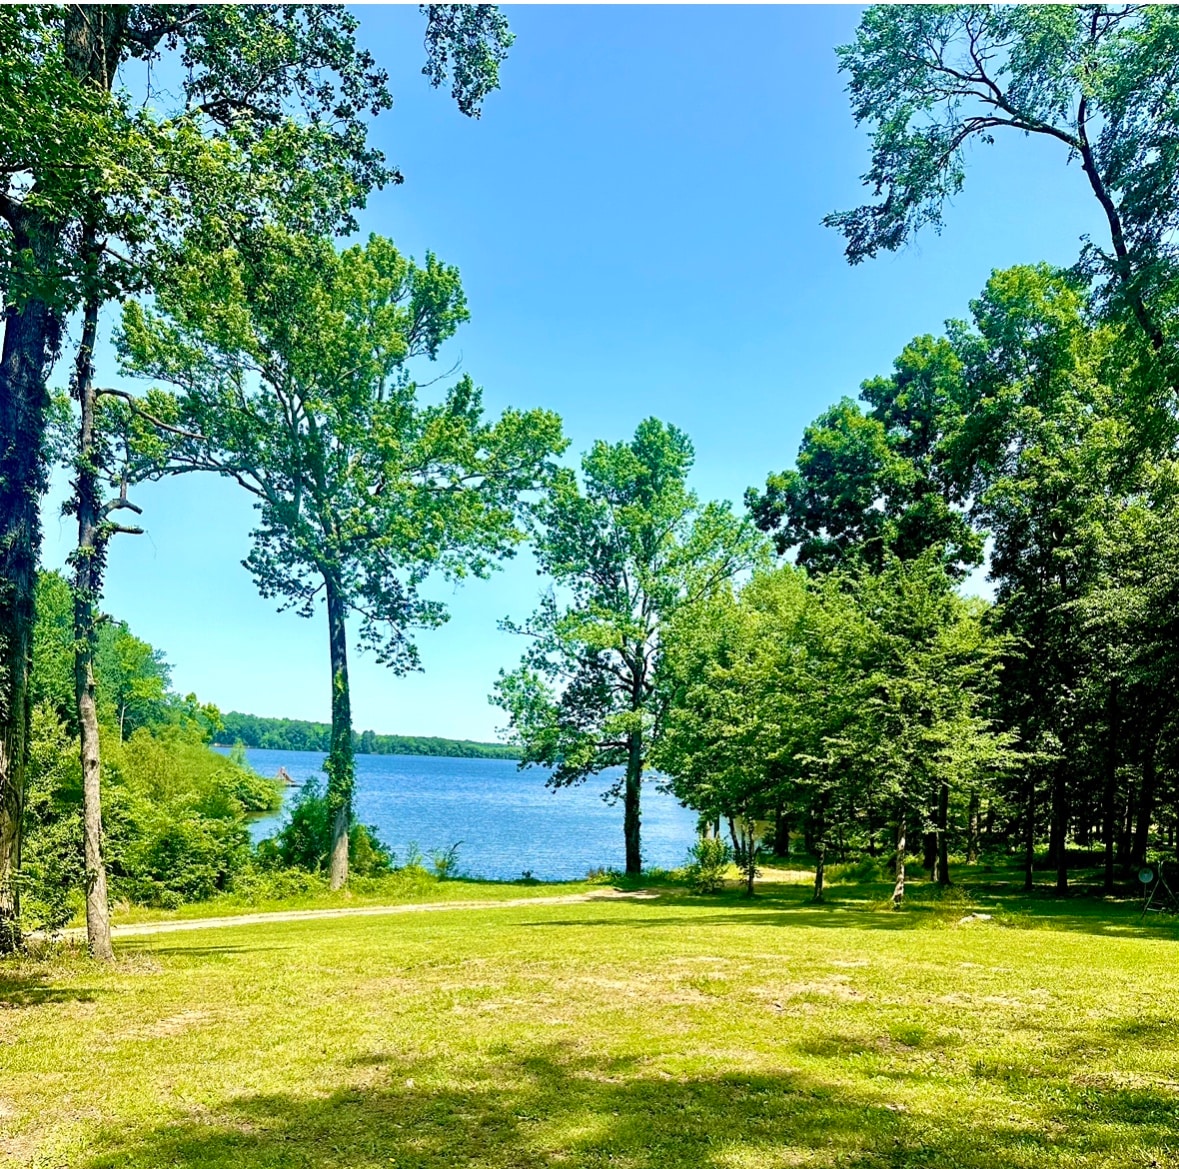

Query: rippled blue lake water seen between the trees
[[221, 751, 696, 880]]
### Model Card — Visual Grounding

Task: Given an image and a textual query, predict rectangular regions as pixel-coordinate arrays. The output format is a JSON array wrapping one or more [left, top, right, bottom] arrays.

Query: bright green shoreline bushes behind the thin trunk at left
[[22, 584, 282, 929]]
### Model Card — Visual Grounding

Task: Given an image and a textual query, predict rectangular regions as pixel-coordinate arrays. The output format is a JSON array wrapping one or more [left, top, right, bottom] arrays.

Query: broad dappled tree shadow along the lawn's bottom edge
[[84, 1046, 1179, 1169]]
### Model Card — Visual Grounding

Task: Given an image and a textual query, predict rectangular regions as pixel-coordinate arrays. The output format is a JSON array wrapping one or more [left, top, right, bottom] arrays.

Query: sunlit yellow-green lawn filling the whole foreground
[[0, 883, 1179, 1169]]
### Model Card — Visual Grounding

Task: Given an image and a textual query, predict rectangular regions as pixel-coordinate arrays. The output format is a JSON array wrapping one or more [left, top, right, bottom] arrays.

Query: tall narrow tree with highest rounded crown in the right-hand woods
[[947, 265, 1135, 891]]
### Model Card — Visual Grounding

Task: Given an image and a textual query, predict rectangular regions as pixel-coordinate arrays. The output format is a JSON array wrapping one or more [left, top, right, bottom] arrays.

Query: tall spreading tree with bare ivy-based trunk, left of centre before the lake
[[121, 229, 564, 887]]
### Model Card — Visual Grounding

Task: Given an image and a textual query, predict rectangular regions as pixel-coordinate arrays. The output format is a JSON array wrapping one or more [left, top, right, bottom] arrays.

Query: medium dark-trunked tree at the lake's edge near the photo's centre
[[493, 418, 756, 873]]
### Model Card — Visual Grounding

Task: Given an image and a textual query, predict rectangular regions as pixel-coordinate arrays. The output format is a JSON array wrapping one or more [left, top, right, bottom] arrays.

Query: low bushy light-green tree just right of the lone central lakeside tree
[[653, 567, 863, 900]]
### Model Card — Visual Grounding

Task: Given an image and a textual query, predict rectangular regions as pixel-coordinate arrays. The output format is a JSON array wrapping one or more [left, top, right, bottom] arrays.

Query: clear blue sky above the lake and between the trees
[[44, 5, 1101, 738]]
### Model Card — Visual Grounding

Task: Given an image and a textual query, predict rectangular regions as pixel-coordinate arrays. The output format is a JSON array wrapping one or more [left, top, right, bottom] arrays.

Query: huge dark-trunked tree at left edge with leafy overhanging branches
[[0, 5, 511, 950]]
